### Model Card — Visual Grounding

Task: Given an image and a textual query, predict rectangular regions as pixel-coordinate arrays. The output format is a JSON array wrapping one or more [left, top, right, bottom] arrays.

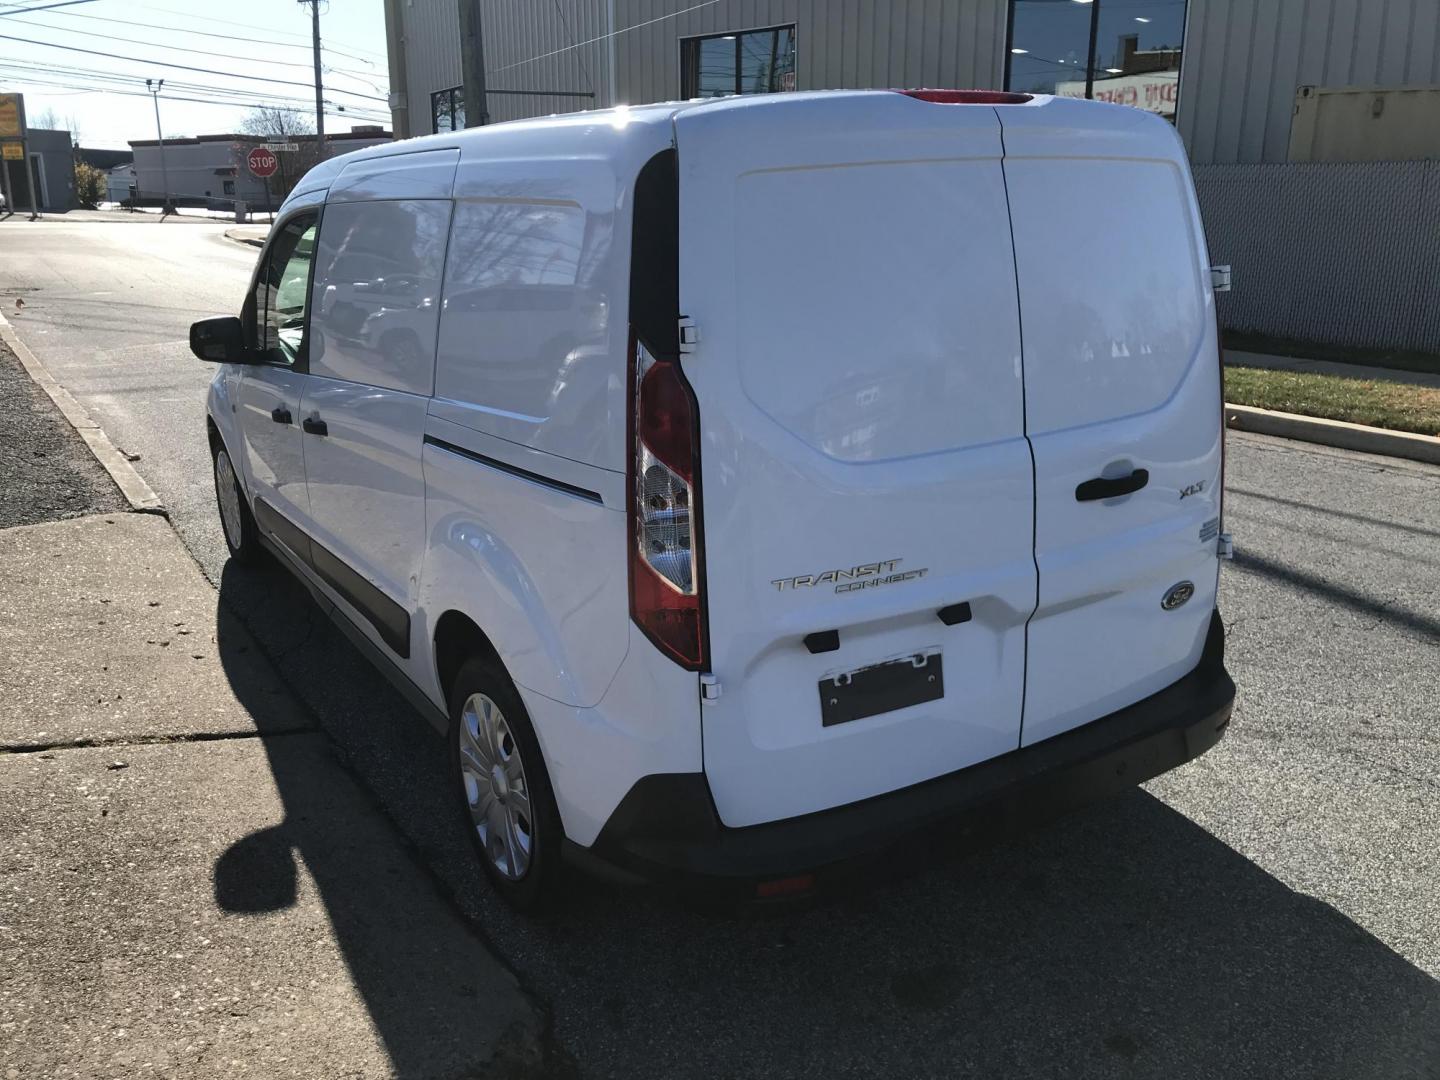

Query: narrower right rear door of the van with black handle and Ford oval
[[996, 98, 1223, 746]]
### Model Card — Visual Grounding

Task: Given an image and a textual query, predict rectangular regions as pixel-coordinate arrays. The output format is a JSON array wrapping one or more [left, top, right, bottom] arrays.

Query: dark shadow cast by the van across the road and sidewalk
[[216, 564, 1440, 1079]]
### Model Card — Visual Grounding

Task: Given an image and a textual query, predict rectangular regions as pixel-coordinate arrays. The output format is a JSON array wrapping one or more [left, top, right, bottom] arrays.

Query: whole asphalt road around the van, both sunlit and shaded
[[0, 225, 1440, 1077]]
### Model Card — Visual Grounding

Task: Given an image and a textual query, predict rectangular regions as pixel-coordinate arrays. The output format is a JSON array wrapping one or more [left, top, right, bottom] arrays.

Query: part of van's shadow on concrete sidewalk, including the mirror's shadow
[[213, 569, 560, 1079]]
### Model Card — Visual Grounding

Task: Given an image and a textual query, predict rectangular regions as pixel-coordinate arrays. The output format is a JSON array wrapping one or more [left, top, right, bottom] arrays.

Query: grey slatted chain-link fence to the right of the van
[[1194, 161, 1440, 353]]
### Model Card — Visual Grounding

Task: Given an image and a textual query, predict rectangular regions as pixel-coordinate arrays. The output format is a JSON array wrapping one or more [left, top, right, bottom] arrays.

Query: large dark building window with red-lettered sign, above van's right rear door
[[1005, 0, 1185, 122]]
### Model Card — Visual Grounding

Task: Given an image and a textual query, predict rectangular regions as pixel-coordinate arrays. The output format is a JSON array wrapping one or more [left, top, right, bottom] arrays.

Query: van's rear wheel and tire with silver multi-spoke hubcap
[[449, 658, 564, 914]]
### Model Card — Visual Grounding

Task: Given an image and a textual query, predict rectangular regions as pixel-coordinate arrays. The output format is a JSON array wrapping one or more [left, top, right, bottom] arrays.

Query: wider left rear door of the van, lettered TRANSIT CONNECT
[[675, 91, 1036, 827]]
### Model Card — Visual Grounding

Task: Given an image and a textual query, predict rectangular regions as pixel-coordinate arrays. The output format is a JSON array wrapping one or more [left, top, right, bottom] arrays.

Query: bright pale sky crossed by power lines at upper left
[[0, 0, 390, 150]]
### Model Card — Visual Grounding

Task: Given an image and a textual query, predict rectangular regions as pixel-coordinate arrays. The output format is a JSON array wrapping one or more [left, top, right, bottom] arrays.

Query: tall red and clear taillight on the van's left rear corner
[[628, 334, 706, 671]]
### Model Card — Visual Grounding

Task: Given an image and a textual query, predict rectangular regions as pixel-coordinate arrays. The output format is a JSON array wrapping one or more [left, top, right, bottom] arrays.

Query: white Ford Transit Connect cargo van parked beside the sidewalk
[[192, 91, 1234, 906]]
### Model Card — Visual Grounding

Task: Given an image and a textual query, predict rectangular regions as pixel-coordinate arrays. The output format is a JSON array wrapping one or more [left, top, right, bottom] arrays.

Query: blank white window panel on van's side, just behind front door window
[[310, 199, 451, 395]]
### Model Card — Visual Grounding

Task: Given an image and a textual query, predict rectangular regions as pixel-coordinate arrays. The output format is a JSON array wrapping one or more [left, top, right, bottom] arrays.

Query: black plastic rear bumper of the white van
[[570, 612, 1236, 896]]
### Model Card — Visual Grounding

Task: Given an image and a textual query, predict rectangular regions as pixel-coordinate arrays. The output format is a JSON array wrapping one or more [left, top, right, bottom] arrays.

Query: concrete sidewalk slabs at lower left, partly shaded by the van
[[0, 513, 544, 1080]]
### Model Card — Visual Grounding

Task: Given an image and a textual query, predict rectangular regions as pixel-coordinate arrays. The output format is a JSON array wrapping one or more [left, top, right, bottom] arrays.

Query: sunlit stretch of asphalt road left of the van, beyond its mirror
[[0, 215, 259, 580]]
